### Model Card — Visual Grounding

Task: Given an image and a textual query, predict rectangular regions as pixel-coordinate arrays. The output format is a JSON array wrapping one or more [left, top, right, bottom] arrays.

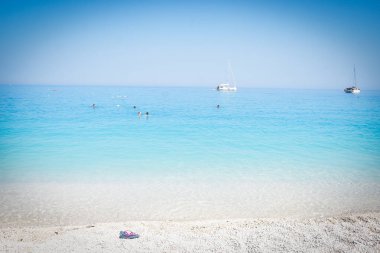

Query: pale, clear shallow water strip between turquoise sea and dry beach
[[0, 180, 380, 228]]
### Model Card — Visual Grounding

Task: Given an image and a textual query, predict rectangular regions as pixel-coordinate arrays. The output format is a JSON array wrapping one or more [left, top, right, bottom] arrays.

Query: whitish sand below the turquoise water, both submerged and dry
[[0, 180, 380, 253]]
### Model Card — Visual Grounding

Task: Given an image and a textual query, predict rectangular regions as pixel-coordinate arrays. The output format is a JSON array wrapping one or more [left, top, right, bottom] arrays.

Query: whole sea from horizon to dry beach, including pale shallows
[[0, 85, 380, 225]]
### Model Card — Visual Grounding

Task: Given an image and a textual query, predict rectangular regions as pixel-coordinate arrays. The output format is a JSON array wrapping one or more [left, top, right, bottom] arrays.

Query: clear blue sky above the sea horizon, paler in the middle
[[0, 0, 380, 89]]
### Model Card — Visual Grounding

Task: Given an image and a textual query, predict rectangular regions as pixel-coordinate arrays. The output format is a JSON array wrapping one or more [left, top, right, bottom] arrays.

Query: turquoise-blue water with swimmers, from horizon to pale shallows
[[0, 85, 380, 182]]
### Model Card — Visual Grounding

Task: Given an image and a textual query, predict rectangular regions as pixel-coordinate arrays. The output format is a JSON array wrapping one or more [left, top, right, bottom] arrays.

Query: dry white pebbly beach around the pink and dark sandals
[[0, 213, 380, 253]]
